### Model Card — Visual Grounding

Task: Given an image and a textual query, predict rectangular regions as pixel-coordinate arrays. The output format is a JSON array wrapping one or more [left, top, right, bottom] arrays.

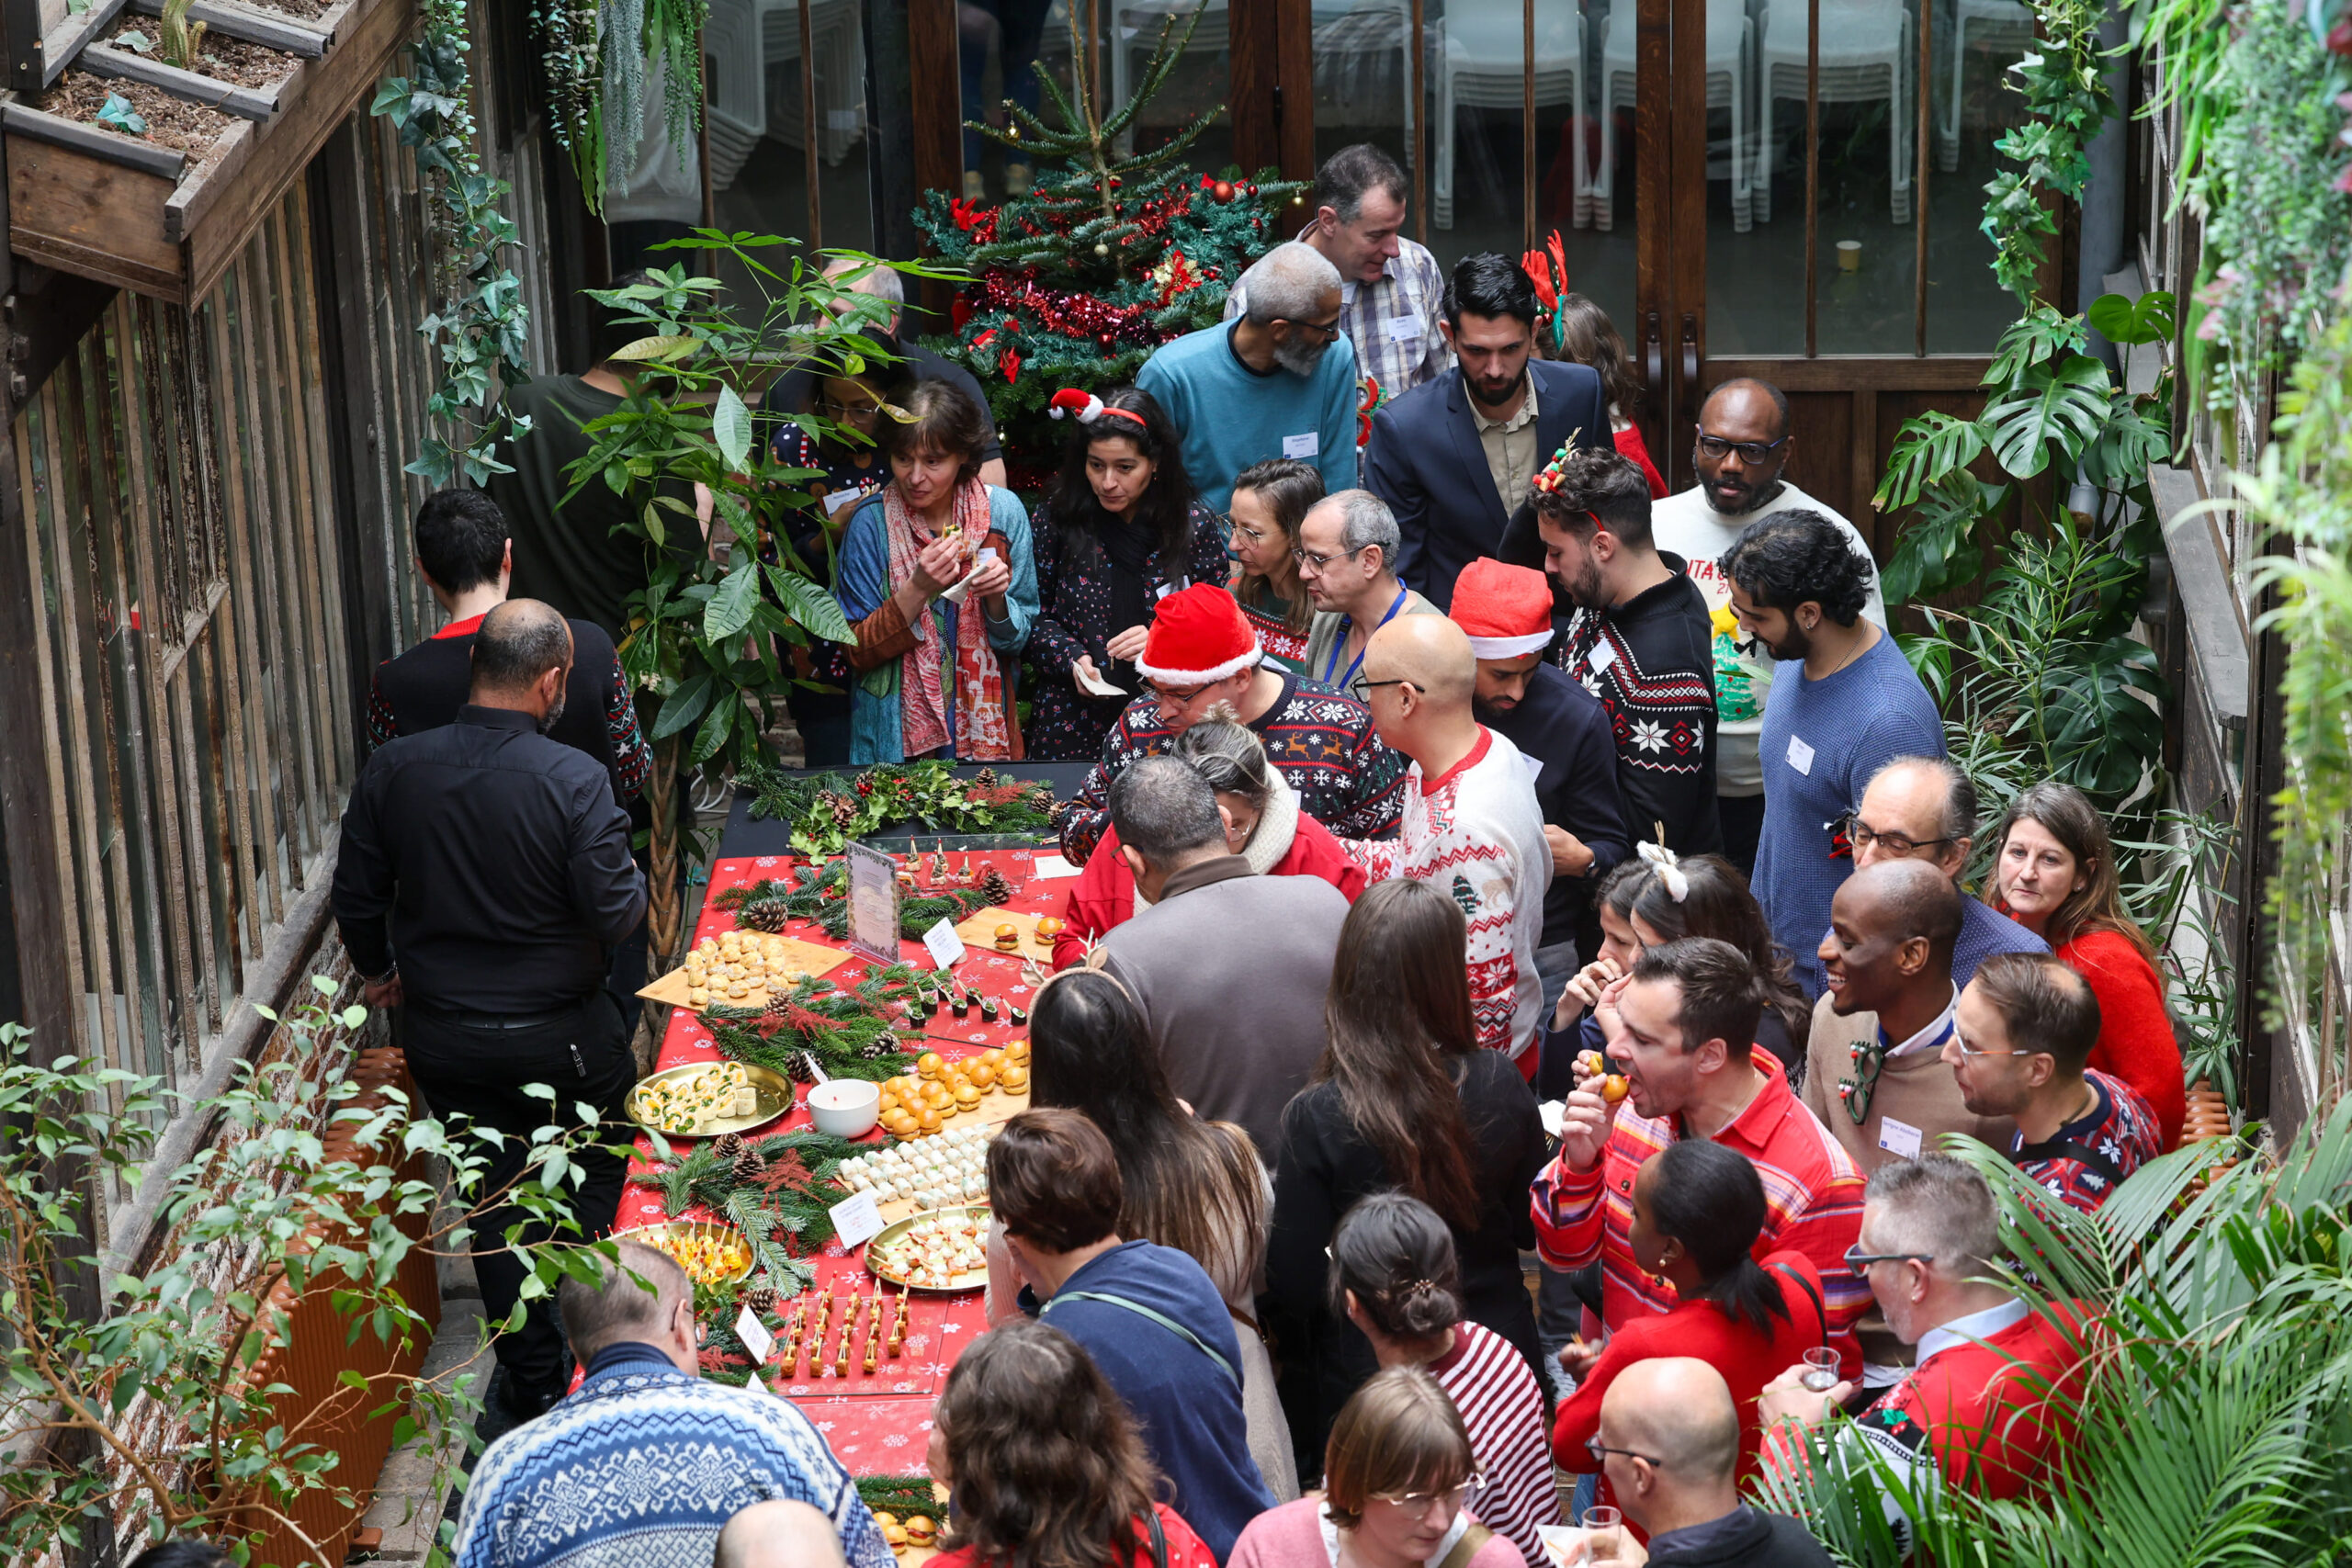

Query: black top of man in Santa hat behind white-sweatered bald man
[[1477, 663, 1633, 962]]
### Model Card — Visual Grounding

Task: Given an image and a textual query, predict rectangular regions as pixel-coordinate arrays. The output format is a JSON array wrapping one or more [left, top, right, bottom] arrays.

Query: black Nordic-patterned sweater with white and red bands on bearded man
[[1555, 550, 1724, 856]]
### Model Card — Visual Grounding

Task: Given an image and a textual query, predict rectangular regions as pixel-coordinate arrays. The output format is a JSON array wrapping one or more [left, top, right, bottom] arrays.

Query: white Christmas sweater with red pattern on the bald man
[[1348, 724, 1553, 1077]]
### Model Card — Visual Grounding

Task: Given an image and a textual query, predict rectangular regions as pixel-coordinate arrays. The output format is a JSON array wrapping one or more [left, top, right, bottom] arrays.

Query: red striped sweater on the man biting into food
[[1533, 1051, 1870, 1378]]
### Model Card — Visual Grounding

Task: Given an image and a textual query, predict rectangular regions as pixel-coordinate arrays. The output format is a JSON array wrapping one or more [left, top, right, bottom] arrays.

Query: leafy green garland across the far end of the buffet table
[[743, 761, 1054, 858]]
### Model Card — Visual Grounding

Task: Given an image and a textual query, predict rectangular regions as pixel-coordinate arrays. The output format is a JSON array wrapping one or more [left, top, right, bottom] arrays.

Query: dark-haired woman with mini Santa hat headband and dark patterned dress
[[1028, 386, 1226, 761]]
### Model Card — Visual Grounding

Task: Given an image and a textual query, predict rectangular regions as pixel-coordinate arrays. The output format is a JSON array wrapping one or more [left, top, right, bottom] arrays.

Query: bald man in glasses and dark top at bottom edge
[[1592, 1357, 1830, 1568]]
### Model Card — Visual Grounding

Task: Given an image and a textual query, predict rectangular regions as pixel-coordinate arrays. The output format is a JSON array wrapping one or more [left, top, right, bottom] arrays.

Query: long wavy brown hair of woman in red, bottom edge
[[936, 1316, 1159, 1568]]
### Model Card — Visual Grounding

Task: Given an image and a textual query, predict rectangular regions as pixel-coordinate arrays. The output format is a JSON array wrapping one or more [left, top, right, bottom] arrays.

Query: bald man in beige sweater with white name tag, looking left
[[1804, 861, 2016, 1176]]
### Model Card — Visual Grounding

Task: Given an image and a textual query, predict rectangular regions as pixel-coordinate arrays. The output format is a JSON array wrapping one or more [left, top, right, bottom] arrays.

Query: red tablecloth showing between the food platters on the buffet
[[618, 849, 1072, 1476]]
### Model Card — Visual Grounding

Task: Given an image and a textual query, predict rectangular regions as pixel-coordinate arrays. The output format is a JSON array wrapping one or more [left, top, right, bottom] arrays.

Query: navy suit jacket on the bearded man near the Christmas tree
[[1364, 360, 1613, 609]]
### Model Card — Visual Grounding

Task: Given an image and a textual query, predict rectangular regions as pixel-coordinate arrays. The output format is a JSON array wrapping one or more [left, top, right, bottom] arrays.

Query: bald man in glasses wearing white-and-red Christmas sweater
[[1345, 616, 1553, 1079]]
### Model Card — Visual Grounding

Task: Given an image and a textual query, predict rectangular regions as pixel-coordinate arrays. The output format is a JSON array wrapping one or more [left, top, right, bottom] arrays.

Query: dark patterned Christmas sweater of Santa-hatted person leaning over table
[[1061, 674, 1404, 865]]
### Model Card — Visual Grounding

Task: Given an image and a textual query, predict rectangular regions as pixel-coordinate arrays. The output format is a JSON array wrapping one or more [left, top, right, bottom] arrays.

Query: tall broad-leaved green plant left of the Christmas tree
[[570, 245, 945, 959]]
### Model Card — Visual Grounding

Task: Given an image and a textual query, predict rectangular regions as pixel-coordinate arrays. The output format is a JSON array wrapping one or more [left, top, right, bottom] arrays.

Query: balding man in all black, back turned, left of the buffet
[[332, 600, 644, 1427]]
